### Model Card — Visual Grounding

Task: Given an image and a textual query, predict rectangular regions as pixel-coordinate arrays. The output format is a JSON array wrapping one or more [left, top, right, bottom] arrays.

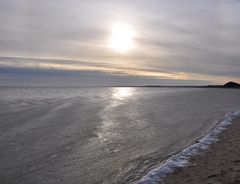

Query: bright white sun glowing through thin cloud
[[109, 23, 134, 52]]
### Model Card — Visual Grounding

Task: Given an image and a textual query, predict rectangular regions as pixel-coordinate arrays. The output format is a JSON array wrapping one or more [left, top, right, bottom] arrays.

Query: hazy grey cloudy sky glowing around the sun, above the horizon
[[0, 0, 240, 86]]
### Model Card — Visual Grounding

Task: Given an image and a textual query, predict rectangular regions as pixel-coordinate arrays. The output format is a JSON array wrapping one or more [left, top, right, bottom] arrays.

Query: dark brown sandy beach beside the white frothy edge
[[163, 118, 240, 184]]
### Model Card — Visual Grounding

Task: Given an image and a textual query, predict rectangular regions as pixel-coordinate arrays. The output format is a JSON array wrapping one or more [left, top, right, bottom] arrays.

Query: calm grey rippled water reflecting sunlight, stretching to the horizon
[[0, 88, 240, 184]]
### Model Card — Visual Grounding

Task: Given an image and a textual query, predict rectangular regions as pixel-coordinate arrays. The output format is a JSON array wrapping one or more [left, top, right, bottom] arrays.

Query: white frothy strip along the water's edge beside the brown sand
[[137, 111, 240, 184]]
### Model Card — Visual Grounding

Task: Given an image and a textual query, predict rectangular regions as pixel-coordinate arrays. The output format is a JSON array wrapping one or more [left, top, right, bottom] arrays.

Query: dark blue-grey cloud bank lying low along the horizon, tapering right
[[0, 67, 214, 86]]
